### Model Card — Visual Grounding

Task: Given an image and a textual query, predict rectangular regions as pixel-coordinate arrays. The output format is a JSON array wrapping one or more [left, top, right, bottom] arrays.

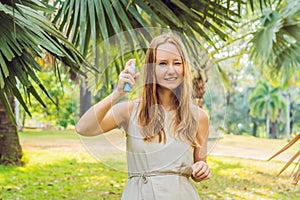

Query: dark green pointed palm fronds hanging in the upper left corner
[[0, 0, 88, 122]]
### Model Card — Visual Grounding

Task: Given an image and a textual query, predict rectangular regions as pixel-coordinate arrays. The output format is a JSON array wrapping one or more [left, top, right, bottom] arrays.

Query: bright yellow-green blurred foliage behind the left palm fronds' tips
[[21, 71, 79, 129]]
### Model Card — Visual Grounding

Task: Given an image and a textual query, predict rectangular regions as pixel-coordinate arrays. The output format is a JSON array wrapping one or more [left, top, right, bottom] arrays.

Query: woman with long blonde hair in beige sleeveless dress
[[76, 34, 211, 200]]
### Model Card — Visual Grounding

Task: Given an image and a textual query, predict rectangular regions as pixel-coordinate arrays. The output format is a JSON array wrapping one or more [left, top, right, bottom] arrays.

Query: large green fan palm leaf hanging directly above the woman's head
[[54, 0, 242, 85]]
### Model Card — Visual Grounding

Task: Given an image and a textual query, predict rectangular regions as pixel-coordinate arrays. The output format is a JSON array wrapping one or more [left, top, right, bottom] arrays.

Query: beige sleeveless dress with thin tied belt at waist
[[122, 103, 199, 200]]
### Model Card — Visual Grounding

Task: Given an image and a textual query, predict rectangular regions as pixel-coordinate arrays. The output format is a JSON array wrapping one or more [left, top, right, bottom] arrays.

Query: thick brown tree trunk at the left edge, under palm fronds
[[0, 97, 23, 165]]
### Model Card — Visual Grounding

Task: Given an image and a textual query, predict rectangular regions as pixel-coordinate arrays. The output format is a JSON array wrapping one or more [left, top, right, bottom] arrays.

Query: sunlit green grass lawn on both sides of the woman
[[0, 130, 300, 200]]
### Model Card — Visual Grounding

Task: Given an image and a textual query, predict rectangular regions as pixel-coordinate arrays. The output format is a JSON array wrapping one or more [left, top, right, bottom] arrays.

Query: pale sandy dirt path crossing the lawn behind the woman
[[20, 132, 300, 162]]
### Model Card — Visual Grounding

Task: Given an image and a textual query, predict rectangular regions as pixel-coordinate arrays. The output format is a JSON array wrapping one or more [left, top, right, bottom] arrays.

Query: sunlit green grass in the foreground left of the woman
[[0, 151, 127, 199]]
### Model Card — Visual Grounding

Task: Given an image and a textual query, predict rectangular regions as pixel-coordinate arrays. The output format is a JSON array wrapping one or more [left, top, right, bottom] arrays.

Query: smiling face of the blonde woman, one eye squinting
[[155, 43, 183, 90]]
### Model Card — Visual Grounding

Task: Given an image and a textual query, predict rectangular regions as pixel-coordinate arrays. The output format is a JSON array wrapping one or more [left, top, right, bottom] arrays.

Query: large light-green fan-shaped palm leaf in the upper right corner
[[251, 0, 300, 87]]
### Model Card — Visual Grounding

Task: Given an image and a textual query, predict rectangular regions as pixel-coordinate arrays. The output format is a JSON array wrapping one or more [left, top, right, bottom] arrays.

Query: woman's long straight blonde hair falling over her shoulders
[[138, 33, 198, 146]]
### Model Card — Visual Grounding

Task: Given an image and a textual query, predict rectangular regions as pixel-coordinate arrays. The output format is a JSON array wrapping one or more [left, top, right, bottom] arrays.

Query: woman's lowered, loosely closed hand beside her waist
[[192, 160, 211, 182]]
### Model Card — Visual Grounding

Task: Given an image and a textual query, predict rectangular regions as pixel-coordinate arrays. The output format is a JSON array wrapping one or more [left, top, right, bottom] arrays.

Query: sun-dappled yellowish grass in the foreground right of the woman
[[197, 157, 300, 199]]
